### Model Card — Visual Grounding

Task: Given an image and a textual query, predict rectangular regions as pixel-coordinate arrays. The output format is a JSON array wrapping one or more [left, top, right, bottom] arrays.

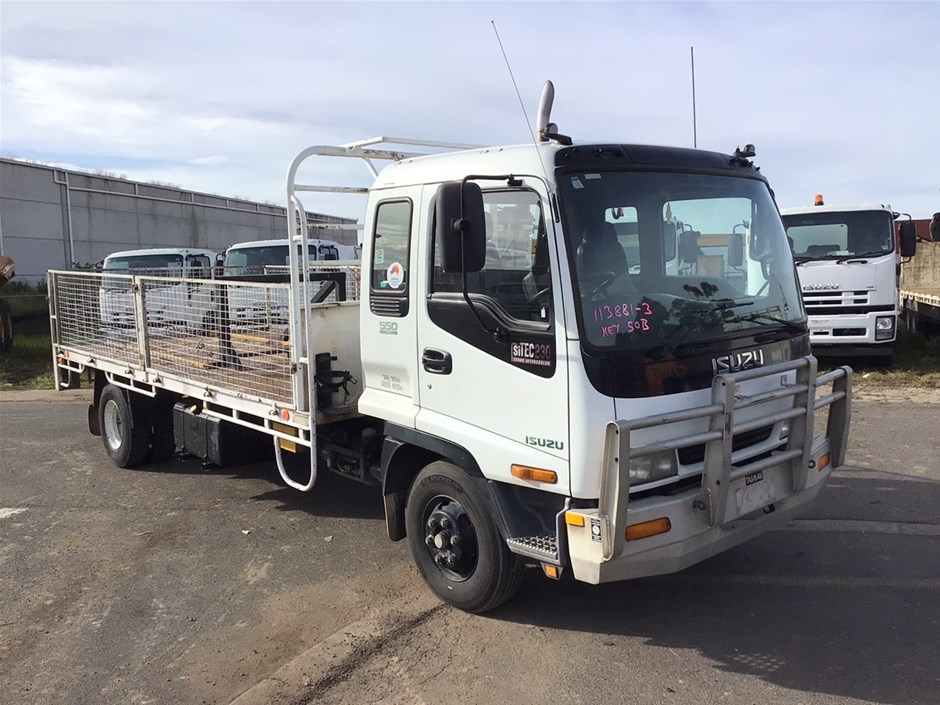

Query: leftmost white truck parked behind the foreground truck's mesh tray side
[[98, 247, 216, 334]]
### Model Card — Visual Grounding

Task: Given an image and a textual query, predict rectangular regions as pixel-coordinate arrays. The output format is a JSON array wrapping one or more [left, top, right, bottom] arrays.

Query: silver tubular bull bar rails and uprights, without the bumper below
[[598, 355, 852, 561]]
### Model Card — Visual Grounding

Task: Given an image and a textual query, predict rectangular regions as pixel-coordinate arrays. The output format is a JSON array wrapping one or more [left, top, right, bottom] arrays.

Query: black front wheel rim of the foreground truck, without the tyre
[[424, 496, 479, 582]]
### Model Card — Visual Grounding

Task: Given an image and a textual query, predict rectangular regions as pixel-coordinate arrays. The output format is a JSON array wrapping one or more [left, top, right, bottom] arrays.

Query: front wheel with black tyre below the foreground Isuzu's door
[[405, 462, 523, 613]]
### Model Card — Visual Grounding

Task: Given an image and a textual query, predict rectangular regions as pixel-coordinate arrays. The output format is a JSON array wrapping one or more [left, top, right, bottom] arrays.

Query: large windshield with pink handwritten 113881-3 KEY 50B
[[559, 171, 804, 354]]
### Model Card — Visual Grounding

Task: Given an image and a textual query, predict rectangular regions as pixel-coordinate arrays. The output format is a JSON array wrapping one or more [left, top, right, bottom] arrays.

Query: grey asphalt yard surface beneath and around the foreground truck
[[0, 390, 940, 705]]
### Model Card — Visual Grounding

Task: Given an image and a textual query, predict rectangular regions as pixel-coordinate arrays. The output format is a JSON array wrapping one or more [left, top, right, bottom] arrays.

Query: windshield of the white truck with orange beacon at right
[[783, 211, 894, 262]]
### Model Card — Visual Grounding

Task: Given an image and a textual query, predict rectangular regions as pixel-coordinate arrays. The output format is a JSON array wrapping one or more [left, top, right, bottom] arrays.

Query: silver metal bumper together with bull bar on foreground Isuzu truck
[[565, 357, 851, 583]]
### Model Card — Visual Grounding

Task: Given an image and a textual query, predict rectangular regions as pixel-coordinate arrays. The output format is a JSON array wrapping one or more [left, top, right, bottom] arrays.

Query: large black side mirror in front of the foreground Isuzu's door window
[[434, 181, 486, 273]]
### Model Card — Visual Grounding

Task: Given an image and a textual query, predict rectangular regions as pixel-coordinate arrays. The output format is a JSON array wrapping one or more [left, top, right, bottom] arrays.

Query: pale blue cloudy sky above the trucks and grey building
[[0, 0, 940, 223]]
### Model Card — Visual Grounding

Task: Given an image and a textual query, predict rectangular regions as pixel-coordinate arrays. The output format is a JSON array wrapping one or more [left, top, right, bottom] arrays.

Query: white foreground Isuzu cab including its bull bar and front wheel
[[288, 119, 851, 611]]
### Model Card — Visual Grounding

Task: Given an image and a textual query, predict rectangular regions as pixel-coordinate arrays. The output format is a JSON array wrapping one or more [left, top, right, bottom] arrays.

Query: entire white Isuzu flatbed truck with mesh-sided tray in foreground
[[49, 84, 851, 612]]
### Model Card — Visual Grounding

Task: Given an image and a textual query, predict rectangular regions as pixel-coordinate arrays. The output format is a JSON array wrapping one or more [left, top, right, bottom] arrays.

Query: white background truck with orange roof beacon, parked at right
[[780, 195, 917, 365]]
